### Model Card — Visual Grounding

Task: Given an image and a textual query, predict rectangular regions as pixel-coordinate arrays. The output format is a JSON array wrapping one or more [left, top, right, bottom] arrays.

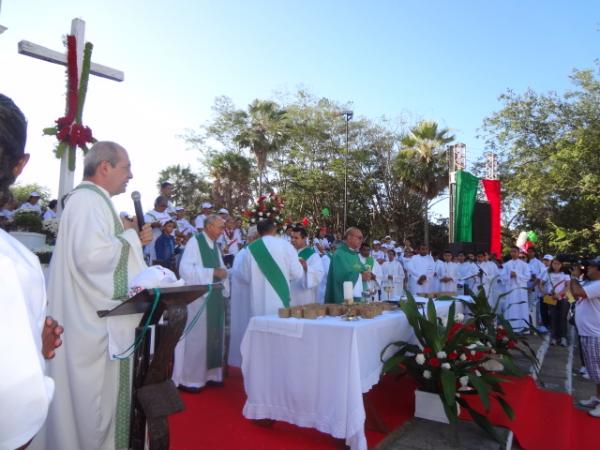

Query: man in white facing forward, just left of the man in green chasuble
[[290, 227, 323, 306]]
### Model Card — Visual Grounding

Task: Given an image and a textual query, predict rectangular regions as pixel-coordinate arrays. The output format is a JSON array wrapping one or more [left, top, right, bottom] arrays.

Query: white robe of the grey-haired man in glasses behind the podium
[[173, 233, 229, 388]]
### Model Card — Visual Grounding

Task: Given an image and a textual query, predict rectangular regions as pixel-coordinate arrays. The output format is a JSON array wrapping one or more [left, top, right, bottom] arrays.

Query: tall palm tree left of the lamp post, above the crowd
[[234, 100, 287, 195]]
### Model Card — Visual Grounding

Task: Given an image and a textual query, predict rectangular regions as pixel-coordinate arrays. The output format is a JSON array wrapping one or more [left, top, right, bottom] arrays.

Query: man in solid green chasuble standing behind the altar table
[[325, 227, 371, 303]]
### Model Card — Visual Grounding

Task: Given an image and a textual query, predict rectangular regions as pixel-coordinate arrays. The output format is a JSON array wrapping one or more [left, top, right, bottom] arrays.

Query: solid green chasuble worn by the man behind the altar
[[325, 243, 365, 303]]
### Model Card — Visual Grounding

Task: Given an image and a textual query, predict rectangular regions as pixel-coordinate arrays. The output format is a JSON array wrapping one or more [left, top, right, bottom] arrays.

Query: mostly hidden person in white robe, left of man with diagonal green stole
[[227, 226, 258, 367]]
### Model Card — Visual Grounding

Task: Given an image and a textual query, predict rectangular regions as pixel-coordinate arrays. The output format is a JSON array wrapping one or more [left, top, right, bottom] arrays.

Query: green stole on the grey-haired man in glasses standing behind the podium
[[196, 233, 225, 369]]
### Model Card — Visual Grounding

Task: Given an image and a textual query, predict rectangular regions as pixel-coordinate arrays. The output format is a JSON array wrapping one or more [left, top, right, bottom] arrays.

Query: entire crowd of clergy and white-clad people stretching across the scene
[[0, 90, 600, 450]]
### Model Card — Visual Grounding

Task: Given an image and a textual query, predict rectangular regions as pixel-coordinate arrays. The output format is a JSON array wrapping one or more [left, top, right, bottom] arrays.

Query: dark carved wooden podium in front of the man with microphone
[[97, 285, 216, 450]]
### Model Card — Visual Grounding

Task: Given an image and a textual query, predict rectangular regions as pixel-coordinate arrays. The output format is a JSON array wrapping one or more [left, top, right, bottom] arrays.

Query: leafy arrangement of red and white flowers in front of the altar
[[381, 292, 517, 439]]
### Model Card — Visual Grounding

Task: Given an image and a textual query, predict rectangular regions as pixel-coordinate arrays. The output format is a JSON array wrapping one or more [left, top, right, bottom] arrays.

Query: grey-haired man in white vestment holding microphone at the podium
[[46, 142, 152, 450]]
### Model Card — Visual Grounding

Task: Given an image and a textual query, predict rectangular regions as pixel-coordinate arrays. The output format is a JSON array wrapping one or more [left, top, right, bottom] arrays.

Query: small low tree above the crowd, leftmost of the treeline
[[158, 164, 212, 216]]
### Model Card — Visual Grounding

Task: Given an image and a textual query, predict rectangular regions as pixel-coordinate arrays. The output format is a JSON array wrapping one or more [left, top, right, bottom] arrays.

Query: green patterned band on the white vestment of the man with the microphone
[[74, 183, 131, 449]]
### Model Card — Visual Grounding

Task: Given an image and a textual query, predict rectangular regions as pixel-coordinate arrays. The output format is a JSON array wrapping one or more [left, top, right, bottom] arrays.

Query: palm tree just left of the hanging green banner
[[394, 120, 454, 245]]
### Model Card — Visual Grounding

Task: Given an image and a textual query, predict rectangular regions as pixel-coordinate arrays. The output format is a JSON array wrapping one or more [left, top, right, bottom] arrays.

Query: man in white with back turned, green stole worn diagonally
[[240, 220, 304, 316]]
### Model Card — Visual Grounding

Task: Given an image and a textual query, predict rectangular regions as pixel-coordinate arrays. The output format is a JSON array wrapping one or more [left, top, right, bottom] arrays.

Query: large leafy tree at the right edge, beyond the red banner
[[483, 66, 600, 255]]
